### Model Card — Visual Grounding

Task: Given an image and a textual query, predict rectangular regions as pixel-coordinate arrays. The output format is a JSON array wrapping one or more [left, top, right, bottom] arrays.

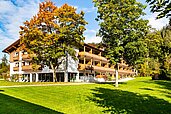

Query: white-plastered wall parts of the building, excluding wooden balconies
[[10, 49, 79, 82]]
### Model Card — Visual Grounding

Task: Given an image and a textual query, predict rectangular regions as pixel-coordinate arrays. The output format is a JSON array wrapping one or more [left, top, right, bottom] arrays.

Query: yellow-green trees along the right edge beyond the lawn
[[140, 26, 171, 79]]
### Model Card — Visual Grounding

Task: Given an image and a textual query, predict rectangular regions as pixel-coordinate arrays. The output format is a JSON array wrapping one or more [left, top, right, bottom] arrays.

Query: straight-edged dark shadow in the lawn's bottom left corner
[[0, 93, 64, 114]]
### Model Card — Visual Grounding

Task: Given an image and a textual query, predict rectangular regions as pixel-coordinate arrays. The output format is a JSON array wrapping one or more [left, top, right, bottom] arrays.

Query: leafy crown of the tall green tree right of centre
[[94, 0, 148, 86]]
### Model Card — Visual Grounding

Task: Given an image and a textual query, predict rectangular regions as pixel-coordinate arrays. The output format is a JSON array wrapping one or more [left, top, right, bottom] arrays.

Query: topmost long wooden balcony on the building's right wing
[[79, 52, 109, 63]]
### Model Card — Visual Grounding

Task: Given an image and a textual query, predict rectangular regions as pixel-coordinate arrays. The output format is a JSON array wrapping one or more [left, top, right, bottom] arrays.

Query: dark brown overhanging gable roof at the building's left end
[[2, 39, 20, 53]]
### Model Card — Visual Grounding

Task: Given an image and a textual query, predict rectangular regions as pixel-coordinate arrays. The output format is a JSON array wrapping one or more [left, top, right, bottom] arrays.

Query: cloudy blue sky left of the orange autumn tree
[[0, 0, 40, 58]]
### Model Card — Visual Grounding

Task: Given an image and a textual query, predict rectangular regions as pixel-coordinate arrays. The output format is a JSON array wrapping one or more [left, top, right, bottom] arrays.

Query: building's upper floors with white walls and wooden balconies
[[6, 45, 135, 80]]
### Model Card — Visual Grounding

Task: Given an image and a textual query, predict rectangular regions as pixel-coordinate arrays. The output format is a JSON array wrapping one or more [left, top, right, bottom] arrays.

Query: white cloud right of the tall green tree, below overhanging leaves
[[148, 13, 169, 30]]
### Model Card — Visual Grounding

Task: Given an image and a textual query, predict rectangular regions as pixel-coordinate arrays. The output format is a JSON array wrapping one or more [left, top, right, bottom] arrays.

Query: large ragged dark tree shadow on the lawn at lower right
[[88, 88, 171, 114]]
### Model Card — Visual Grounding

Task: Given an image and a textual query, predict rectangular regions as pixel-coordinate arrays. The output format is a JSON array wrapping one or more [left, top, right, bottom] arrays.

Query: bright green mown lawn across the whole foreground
[[0, 77, 171, 114]]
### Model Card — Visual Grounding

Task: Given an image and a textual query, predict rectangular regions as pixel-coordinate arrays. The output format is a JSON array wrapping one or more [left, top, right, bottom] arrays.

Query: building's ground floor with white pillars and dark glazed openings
[[17, 71, 135, 82]]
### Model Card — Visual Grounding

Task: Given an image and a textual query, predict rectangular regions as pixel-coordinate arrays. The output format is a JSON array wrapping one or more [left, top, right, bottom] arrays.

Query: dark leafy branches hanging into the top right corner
[[146, 0, 171, 19]]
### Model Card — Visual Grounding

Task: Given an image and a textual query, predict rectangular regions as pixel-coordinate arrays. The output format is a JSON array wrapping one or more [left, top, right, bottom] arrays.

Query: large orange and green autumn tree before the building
[[20, 1, 87, 81]]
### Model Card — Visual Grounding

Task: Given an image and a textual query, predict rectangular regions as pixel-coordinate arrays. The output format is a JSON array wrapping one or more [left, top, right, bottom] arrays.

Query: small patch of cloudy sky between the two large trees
[[84, 29, 102, 43]]
